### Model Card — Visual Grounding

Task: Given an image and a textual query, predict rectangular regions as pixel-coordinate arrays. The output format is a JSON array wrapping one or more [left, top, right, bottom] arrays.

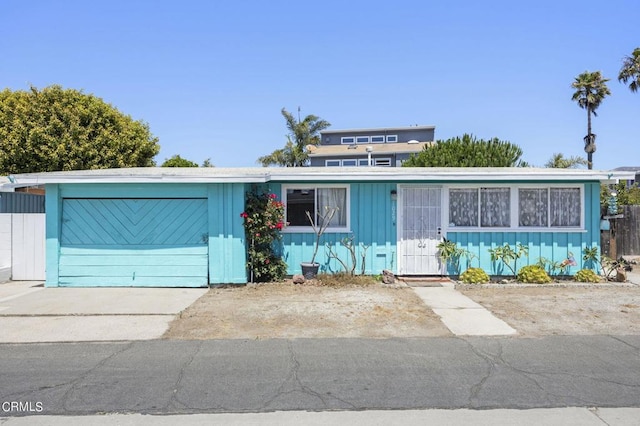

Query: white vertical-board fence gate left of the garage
[[0, 213, 46, 282]]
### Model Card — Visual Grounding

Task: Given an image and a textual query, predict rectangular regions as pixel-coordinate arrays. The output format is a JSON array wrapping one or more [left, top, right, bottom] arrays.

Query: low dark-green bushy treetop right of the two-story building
[[403, 134, 526, 167]]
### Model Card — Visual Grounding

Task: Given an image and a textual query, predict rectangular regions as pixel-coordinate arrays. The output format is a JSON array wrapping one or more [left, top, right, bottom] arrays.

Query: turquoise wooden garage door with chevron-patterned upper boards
[[60, 198, 208, 287]]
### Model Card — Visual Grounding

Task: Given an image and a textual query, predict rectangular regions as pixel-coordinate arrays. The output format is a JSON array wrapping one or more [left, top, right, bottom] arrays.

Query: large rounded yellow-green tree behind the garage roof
[[0, 85, 160, 175]]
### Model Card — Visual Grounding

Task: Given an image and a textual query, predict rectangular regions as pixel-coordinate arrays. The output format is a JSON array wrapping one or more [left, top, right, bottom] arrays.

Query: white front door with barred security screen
[[398, 186, 443, 275]]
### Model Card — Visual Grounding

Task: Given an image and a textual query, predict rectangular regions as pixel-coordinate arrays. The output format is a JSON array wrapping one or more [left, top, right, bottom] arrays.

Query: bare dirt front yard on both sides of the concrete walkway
[[165, 282, 640, 339]]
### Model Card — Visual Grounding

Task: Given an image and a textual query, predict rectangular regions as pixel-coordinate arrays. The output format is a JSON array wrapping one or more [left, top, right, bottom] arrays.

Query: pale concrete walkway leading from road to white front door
[[413, 282, 517, 336]]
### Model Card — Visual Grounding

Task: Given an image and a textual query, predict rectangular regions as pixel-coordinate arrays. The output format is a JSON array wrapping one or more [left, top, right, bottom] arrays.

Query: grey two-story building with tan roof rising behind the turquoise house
[[309, 126, 436, 167]]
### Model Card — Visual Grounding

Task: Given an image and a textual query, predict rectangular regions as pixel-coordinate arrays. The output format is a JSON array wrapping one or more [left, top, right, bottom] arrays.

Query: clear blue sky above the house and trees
[[0, 0, 640, 169]]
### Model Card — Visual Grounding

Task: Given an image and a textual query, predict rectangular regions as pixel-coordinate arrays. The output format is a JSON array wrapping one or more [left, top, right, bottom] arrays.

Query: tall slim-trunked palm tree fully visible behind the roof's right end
[[571, 71, 611, 170]]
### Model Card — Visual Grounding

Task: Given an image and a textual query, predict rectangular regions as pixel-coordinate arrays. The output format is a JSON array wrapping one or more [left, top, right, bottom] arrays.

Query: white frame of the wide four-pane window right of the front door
[[442, 183, 586, 232]]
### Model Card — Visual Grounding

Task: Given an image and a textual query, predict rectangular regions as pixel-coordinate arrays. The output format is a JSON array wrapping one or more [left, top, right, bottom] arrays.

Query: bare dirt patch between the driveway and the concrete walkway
[[165, 282, 451, 339]]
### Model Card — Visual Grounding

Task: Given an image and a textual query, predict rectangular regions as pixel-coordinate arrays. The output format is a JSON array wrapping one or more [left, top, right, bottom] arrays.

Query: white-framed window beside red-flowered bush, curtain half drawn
[[282, 185, 349, 232]]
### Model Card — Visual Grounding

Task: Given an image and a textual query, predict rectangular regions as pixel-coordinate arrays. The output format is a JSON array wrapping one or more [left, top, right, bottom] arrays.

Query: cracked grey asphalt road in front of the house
[[0, 336, 640, 417]]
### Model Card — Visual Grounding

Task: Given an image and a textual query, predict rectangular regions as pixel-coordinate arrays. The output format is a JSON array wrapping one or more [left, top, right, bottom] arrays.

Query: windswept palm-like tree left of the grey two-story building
[[258, 108, 331, 167]]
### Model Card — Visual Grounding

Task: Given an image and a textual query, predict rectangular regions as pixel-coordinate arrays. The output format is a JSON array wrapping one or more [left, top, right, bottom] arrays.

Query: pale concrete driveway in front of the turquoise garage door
[[0, 281, 207, 343]]
